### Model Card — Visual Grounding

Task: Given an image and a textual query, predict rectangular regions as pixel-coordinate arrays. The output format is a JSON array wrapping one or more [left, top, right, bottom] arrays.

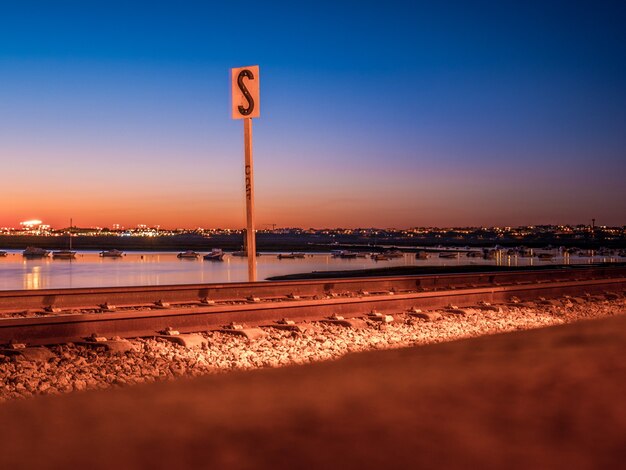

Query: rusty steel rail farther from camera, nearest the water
[[0, 266, 626, 313]]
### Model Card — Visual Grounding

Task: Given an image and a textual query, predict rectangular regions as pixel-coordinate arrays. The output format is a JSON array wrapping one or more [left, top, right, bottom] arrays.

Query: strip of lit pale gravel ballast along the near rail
[[0, 294, 626, 401]]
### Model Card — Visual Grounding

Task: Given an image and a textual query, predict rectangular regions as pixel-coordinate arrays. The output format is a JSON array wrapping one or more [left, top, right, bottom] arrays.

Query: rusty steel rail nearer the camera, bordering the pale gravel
[[0, 277, 626, 345]]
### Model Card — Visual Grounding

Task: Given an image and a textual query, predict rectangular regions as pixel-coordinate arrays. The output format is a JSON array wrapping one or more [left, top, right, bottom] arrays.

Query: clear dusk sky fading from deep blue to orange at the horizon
[[0, 0, 626, 229]]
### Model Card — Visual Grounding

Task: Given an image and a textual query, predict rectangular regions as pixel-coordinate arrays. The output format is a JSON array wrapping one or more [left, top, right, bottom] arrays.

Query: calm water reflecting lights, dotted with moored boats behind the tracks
[[0, 250, 624, 290]]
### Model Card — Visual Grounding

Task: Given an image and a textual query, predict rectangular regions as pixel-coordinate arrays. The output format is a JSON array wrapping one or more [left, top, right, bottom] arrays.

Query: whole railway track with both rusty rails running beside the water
[[0, 266, 626, 345]]
